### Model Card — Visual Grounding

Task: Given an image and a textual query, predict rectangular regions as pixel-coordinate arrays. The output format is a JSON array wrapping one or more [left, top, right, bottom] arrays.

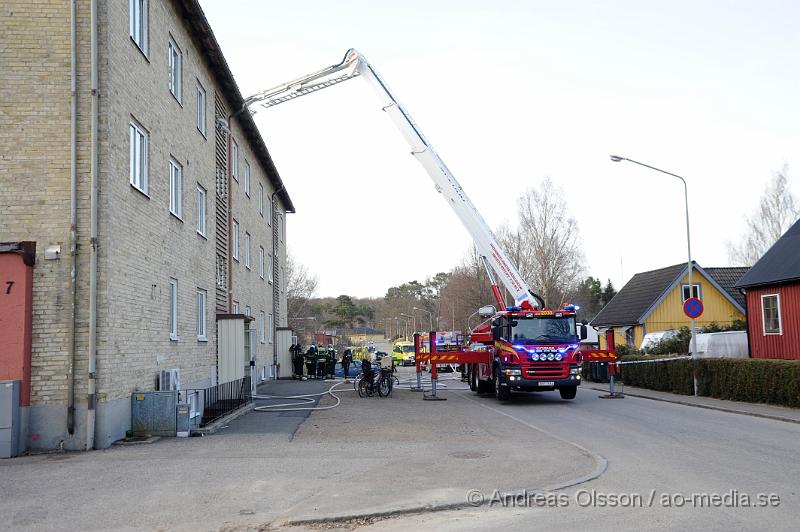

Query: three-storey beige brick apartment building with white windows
[[0, 0, 294, 449]]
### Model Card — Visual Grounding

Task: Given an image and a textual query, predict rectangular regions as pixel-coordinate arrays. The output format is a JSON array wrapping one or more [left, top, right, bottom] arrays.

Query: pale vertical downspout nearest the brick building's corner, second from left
[[86, 0, 99, 450]]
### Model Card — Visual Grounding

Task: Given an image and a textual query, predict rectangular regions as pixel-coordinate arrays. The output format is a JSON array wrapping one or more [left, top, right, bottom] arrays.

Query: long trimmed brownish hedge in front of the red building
[[583, 355, 800, 408]]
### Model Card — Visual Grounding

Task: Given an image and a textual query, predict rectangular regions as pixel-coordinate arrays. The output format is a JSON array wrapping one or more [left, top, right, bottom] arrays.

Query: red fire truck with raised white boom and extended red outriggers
[[238, 48, 615, 400]]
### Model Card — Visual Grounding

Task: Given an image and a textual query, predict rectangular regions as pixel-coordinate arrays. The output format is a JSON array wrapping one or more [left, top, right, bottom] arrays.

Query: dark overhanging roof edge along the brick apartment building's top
[[174, 0, 295, 212]]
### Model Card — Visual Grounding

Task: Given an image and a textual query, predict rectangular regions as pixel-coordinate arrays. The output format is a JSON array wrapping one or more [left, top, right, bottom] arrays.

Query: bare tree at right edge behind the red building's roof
[[728, 165, 800, 266]]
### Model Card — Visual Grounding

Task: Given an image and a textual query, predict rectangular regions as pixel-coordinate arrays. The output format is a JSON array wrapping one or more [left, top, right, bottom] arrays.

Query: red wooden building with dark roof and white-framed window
[[736, 220, 800, 360]]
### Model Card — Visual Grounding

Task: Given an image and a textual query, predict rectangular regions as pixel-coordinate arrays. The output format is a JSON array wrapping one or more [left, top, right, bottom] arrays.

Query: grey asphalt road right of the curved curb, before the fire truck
[[356, 372, 800, 531]]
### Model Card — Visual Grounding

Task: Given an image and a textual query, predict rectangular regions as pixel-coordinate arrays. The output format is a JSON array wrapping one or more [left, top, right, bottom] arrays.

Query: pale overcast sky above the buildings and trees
[[201, 0, 800, 296]]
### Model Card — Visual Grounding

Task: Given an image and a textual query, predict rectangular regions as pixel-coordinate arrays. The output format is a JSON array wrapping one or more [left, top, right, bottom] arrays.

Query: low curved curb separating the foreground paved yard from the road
[[272, 396, 608, 526]]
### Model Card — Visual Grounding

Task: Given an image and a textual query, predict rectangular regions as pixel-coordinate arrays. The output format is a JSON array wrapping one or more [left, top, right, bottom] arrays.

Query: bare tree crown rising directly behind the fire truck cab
[[498, 177, 584, 307]]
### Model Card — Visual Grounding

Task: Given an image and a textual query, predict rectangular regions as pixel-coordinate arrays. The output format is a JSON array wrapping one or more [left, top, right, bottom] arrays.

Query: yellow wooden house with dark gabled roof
[[591, 262, 748, 349]]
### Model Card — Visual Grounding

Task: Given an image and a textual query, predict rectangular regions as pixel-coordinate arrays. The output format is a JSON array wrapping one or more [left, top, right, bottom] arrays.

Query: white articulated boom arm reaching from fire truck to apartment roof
[[245, 48, 544, 308]]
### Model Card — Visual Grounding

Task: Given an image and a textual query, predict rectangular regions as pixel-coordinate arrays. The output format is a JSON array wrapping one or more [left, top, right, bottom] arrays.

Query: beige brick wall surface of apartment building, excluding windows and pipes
[[0, 0, 286, 440]]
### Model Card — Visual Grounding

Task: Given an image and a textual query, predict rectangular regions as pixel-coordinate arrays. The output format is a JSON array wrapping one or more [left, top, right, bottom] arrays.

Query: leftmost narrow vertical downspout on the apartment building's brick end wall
[[67, 0, 78, 436]]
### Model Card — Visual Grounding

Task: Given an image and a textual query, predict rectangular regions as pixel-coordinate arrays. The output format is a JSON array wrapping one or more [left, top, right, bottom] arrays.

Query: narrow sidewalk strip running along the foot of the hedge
[[583, 381, 800, 423]]
